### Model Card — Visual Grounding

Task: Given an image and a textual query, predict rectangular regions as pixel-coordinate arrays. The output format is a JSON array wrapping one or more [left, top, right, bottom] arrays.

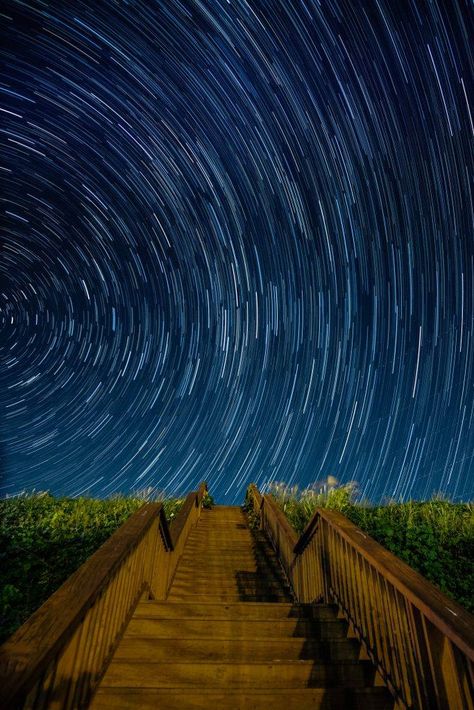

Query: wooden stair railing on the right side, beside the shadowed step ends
[[247, 485, 474, 710]]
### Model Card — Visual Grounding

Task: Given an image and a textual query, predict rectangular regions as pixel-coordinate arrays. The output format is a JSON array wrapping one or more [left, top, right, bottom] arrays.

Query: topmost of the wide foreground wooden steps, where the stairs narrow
[[134, 601, 336, 620]]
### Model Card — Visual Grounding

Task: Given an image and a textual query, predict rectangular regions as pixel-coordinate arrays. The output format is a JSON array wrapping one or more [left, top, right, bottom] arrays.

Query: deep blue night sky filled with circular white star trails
[[0, 0, 474, 503]]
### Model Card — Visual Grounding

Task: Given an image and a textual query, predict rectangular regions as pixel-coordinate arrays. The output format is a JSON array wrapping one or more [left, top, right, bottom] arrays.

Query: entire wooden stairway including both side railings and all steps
[[0, 484, 474, 710]]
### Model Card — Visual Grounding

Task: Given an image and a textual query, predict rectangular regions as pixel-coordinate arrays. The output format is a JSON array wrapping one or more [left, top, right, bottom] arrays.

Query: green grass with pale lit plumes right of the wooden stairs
[[266, 479, 474, 613]]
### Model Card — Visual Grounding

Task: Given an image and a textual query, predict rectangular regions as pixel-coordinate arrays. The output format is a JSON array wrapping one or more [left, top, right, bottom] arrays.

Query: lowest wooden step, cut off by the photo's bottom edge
[[90, 687, 394, 710]]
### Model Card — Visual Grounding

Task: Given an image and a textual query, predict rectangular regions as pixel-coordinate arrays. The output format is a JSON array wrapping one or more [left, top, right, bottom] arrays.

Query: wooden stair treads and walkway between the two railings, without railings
[[91, 506, 394, 710]]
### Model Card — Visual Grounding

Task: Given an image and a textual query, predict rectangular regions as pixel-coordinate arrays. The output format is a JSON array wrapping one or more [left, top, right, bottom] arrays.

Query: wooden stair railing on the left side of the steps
[[0, 483, 207, 710]]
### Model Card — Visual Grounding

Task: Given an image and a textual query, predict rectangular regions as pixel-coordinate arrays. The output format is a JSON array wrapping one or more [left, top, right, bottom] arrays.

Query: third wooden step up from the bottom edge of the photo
[[114, 636, 360, 662]]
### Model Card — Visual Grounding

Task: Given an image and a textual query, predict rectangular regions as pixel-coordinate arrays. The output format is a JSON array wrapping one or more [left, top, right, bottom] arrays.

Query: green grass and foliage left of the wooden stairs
[[0, 492, 184, 643]]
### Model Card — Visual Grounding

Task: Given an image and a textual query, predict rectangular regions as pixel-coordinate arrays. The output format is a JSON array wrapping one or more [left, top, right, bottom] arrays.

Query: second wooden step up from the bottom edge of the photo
[[102, 659, 375, 689]]
